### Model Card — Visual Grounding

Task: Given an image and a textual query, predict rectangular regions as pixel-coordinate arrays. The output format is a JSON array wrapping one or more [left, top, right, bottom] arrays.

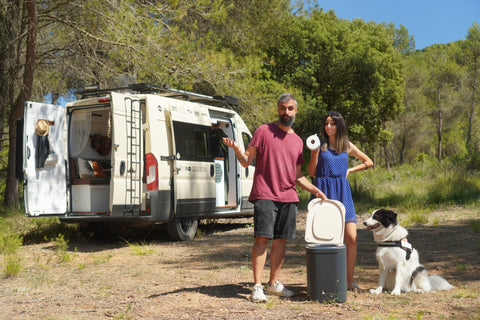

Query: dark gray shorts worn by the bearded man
[[253, 199, 298, 240]]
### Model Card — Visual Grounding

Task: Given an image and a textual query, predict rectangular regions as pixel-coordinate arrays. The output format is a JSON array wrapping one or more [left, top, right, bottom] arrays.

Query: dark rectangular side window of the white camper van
[[173, 121, 213, 161]]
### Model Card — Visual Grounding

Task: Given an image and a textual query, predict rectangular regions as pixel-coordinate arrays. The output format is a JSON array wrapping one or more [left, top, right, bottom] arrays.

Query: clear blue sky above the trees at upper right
[[315, 0, 480, 49]]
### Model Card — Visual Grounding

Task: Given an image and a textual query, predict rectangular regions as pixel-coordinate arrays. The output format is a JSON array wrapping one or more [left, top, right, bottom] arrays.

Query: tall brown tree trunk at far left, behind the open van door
[[4, 0, 38, 208]]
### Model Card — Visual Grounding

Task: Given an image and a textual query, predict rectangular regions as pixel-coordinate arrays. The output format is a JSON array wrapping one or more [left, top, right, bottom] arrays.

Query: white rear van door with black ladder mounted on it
[[110, 92, 143, 217]]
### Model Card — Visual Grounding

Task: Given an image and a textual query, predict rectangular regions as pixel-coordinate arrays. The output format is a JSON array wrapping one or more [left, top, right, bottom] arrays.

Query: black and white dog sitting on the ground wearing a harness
[[363, 209, 453, 295]]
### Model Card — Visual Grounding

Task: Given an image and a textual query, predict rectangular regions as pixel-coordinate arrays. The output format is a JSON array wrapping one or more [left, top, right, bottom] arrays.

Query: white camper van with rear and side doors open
[[23, 84, 255, 240]]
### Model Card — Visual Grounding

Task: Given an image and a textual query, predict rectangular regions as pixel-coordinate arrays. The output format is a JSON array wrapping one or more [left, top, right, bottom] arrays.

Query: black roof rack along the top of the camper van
[[78, 83, 238, 111]]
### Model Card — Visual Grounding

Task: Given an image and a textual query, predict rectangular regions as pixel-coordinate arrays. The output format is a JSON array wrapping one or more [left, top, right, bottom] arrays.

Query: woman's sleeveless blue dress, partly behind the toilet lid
[[314, 149, 357, 222]]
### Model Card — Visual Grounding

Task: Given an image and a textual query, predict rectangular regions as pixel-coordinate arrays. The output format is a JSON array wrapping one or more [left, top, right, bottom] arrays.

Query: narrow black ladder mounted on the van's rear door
[[124, 99, 142, 216]]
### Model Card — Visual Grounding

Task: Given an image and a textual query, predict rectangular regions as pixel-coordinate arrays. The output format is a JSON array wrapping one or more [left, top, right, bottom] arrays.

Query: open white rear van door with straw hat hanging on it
[[23, 102, 67, 216]]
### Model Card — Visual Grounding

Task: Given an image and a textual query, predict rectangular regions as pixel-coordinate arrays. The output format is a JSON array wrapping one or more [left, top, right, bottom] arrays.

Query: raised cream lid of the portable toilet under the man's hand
[[305, 198, 345, 245]]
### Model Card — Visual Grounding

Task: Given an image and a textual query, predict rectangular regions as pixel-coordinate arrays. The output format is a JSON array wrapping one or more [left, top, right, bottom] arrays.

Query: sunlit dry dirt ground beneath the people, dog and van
[[0, 210, 480, 319]]
